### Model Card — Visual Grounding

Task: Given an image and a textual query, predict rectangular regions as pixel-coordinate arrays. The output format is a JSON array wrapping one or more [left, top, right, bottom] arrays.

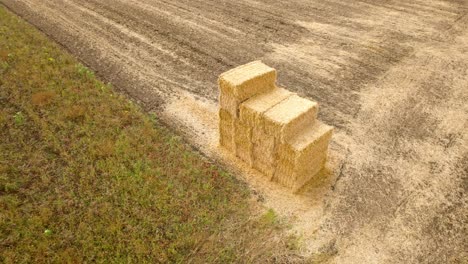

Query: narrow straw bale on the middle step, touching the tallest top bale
[[239, 88, 293, 127]]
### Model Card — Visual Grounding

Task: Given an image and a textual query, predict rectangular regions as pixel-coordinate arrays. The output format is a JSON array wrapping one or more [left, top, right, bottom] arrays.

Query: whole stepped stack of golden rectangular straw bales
[[219, 61, 333, 190]]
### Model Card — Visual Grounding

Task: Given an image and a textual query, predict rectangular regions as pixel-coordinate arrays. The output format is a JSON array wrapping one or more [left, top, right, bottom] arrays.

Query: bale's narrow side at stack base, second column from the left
[[234, 120, 253, 166]]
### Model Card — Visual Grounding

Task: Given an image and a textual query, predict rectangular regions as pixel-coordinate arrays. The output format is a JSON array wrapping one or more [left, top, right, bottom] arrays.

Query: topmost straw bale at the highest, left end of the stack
[[218, 61, 276, 118]]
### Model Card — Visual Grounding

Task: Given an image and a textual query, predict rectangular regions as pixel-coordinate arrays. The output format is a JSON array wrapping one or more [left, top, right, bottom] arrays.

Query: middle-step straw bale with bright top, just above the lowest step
[[262, 95, 318, 143]]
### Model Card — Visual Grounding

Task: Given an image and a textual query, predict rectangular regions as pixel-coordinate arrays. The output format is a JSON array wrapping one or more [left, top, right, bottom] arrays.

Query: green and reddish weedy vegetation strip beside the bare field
[[0, 6, 301, 263]]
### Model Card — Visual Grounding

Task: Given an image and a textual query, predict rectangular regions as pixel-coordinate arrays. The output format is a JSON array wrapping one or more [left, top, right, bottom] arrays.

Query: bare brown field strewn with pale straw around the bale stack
[[0, 0, 468, 263]]
